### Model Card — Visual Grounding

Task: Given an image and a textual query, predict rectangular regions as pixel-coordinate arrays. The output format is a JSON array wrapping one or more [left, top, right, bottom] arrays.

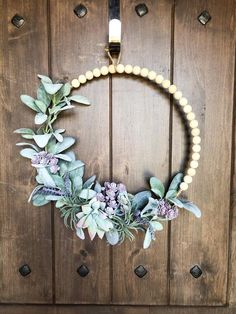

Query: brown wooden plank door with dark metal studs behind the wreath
[[0, 0, 236, 314]]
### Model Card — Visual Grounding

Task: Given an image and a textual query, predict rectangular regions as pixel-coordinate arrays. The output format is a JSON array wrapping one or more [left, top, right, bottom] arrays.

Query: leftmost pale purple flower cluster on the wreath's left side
[[31, 151, 60, 174]]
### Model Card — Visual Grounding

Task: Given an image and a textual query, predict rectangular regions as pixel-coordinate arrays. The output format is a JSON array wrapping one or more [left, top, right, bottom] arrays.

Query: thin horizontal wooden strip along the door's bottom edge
[[0, 305, 236, 314]]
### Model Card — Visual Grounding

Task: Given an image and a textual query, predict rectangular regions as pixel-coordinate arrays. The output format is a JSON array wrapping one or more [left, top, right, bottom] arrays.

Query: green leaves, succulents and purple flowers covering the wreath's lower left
[[14, 75, 201, 249]]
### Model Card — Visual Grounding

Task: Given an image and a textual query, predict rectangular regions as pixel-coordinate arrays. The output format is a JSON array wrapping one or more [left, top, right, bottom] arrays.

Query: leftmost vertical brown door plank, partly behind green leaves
[[0, 0, 52, 303]]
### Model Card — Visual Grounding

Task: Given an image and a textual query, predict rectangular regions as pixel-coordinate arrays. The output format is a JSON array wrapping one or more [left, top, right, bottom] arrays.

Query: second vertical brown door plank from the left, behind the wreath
[[50, 0, 110, 303]]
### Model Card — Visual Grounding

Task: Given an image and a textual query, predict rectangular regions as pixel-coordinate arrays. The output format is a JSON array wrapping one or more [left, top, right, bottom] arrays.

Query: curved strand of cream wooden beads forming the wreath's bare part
[[71, 64, 201, 194]]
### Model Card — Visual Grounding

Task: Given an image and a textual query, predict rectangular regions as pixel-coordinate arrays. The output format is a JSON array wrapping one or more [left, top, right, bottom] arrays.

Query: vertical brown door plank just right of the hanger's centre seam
[[112, 0, 172, 304]]
